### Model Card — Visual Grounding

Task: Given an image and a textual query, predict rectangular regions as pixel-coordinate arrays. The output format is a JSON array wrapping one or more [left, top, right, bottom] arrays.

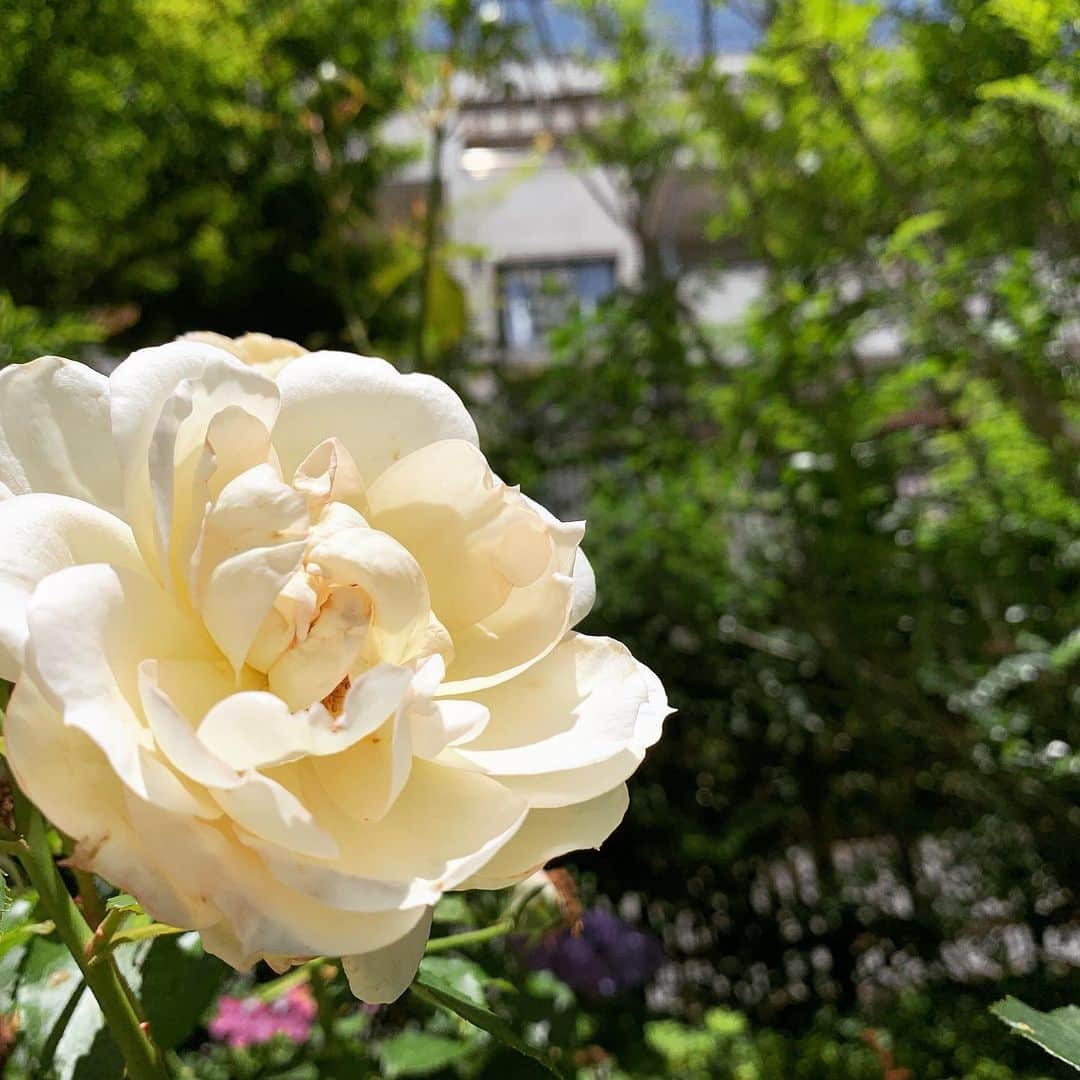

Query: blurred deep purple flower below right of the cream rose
[[525, 908, 664, 998]]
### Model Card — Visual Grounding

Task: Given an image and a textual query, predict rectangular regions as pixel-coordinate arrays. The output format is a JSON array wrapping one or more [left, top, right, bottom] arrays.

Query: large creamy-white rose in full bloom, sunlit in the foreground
[[0, 335, 669, 1001]]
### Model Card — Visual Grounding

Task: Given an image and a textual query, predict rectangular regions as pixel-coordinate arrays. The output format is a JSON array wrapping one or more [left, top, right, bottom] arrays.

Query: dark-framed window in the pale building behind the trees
[[498, 258, 615, 352]]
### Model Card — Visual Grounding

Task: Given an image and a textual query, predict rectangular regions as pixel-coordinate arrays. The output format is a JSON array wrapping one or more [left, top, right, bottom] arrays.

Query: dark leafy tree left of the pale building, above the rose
[[0, 0, 415, 359]]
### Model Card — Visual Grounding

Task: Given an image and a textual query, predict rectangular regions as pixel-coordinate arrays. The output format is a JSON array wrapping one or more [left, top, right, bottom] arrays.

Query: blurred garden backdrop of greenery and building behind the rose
[[0, 0, 1080, 1080]]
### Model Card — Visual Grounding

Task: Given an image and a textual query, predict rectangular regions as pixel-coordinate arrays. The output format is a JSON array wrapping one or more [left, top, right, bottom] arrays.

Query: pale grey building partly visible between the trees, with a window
[[384, 57, 761, 363]]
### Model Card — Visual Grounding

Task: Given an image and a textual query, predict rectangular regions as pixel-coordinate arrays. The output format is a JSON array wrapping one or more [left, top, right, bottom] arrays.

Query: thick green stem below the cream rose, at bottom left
[[15, 789, 168, 1080]]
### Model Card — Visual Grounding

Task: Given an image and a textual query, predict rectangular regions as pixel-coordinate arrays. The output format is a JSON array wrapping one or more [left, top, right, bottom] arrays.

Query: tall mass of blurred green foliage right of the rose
[[479, 2, 1080, 1049]]
